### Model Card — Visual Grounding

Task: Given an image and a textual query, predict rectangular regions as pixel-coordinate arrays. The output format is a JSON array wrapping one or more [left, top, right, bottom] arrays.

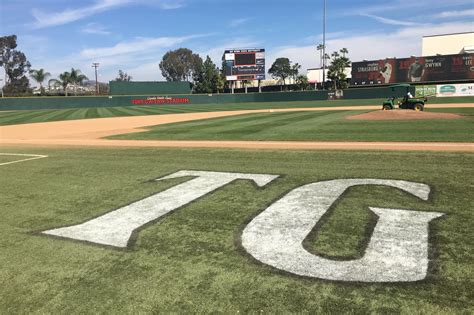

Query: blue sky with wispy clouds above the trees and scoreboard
[[0, 0, 474, 82]]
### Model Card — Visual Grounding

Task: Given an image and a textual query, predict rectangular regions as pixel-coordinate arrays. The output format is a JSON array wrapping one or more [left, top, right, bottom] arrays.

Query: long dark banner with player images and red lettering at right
[[351, 54, 474, 85]]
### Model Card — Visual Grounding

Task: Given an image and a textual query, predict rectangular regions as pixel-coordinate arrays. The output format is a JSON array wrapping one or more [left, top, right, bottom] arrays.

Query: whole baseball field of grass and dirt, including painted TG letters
[[0, 98, 474, 314]]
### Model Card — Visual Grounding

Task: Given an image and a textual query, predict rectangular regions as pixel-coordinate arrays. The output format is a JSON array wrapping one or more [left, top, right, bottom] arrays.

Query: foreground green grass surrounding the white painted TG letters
[[0, 147, 474, 314]]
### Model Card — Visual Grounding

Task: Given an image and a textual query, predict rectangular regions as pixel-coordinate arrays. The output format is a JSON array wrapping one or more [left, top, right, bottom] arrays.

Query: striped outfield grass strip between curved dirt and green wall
[[0, 97, 474, 125]]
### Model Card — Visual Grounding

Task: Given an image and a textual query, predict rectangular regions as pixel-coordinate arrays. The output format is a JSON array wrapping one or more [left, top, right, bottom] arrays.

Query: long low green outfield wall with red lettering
[[0, 88, 414, 110]]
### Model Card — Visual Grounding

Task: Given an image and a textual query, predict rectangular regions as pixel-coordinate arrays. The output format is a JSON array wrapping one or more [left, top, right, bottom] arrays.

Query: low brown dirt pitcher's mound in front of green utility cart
[[347, 109, 462, 120]]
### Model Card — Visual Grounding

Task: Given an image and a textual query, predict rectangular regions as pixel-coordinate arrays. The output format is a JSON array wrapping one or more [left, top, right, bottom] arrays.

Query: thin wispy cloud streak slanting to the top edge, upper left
[[32, 0, 184, 28]]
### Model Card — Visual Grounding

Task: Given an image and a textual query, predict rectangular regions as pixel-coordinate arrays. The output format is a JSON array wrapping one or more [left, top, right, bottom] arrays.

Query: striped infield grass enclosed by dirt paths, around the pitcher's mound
[[111, 108, 474, 142]]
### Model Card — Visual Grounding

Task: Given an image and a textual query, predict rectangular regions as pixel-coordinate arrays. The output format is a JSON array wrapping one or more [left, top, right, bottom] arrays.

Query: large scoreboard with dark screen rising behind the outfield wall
[[224, 49, 265, 81]]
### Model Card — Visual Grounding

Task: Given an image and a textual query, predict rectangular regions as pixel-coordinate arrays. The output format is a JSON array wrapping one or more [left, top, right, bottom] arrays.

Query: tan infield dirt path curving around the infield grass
[[0, 103, 474, 152]]
